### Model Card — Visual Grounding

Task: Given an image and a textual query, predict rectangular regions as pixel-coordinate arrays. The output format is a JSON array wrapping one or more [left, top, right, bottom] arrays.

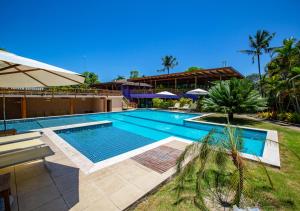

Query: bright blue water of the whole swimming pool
[[1, 110, 266, 162]]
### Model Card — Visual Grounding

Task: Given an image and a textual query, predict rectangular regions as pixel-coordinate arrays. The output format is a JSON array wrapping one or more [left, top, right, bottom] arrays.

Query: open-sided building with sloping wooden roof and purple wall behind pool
[[94, 67, 244, 107]]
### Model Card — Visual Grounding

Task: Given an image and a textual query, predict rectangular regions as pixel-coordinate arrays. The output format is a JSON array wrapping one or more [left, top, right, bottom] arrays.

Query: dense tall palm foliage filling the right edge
[[262, 38, 300, 112]]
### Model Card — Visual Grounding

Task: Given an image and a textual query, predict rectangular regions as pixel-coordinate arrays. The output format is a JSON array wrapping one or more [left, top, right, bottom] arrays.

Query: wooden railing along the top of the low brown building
[[0, 87, 122, 97]]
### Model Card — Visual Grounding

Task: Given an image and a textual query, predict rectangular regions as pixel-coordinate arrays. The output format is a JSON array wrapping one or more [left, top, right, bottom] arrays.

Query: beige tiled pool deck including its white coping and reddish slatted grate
[[0, 111, 280, 211]]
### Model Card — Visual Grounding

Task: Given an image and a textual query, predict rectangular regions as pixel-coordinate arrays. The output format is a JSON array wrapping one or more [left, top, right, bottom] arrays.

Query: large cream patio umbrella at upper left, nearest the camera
[[0, 50, 84, 130]]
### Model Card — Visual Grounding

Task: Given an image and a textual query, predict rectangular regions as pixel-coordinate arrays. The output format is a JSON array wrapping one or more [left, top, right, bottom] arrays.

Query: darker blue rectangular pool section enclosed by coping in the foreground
[[56, 126, 154, 163]]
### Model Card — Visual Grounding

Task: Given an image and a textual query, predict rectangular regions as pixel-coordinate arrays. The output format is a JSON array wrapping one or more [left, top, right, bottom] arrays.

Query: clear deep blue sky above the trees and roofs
[[0, 0, 300, 81]]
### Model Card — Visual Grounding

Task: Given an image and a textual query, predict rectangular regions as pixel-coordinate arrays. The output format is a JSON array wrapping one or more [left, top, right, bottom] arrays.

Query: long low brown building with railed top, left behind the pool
[[0, 88, 123, 119]]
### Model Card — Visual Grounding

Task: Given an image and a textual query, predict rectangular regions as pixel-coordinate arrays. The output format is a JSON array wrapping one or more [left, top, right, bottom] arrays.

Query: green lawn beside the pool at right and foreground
[[135, 114, 300, 211]]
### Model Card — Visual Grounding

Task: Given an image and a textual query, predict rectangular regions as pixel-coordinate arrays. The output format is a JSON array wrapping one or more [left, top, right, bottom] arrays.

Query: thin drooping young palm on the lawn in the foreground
[[175, 125, 273, 210]]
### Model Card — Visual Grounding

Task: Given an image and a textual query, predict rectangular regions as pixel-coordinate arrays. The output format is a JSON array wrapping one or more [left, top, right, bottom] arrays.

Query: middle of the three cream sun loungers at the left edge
[[0, 139, 45, 155]]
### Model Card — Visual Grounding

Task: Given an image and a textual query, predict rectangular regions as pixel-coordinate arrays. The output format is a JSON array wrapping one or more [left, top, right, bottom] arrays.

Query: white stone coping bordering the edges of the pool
[[14, 109, 280, 174]]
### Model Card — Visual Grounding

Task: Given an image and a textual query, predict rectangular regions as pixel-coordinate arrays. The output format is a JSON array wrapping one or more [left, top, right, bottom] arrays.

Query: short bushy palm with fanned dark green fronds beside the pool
[[203, 78, 266, 122]]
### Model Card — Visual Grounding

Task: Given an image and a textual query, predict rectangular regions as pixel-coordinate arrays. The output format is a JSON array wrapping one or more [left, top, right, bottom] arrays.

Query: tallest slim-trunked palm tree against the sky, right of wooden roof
[[240, 30, 275, 92]]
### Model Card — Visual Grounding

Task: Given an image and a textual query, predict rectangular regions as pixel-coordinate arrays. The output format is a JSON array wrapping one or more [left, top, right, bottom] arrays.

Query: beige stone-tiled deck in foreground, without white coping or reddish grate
[[0, 135, 186, 211]]
